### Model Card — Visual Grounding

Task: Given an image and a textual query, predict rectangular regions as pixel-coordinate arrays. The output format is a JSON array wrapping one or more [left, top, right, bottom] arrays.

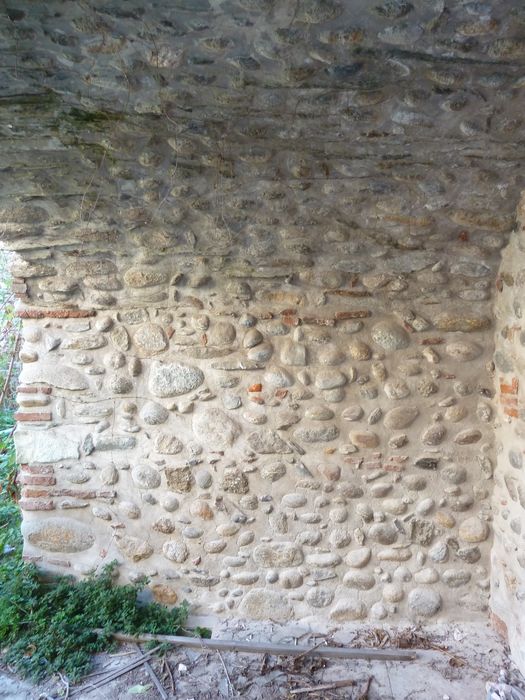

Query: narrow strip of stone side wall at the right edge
[[491, 199, 525, 668]]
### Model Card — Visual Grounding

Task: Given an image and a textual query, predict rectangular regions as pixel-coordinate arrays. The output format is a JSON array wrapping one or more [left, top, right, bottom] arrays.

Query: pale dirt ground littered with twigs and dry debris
[[0, 620, 525, 700]]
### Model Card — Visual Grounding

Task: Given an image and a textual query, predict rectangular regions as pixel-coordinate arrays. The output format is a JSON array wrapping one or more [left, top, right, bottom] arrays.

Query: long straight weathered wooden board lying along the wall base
[[95, 630, 417, 661]]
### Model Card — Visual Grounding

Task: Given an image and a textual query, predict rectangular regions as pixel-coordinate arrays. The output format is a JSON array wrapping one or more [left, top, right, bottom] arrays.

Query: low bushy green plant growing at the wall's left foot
[[0, 560, 192, 681]]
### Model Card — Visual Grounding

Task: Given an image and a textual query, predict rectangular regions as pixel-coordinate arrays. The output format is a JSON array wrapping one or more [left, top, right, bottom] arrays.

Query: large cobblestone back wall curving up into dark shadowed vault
[[0, 0, 525, 664]]
